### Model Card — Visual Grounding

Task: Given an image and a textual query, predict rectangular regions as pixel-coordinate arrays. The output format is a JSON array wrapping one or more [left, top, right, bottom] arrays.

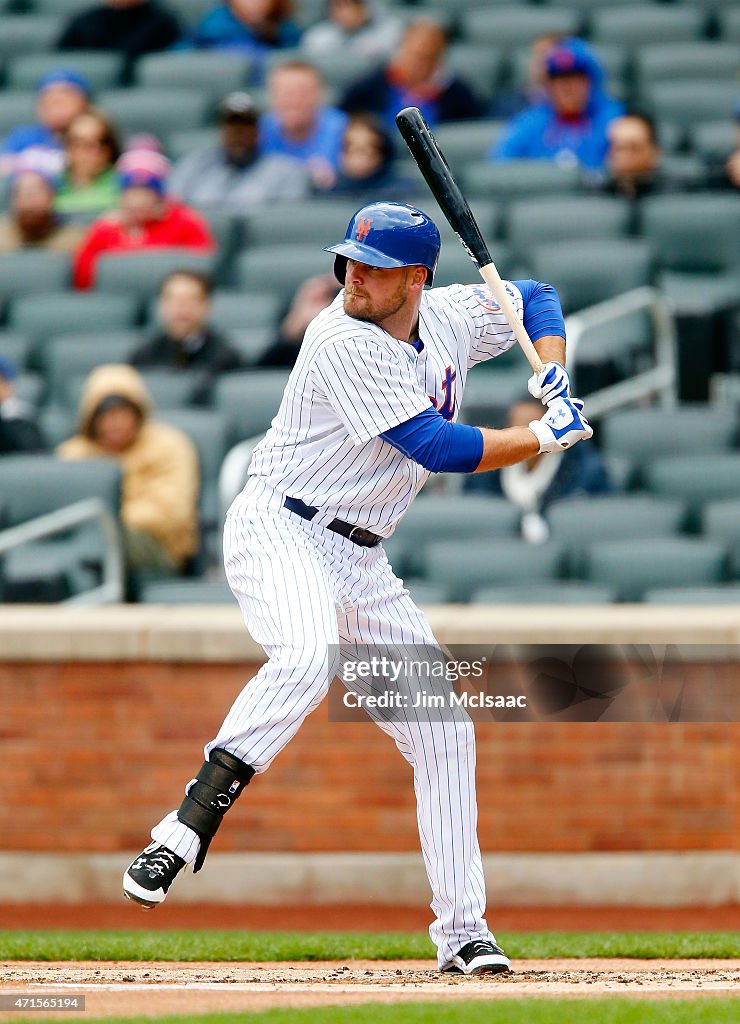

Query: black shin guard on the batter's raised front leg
[[177, 748, 255, 874]]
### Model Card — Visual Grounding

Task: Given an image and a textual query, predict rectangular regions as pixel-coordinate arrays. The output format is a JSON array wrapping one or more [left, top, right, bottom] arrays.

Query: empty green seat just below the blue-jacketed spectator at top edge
[[136, 50, 252, 102]]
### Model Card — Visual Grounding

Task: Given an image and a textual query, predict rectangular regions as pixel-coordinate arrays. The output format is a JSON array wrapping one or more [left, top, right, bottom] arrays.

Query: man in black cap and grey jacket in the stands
[[170, 92, 309, 213]]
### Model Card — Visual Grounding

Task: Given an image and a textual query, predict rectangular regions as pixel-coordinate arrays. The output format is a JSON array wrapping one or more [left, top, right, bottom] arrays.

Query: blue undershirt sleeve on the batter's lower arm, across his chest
[[380, 406, 483, 473]]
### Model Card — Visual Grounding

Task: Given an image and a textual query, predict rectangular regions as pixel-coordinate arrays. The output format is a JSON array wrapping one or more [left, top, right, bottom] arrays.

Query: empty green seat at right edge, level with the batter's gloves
[[599, 404, 738, 463]]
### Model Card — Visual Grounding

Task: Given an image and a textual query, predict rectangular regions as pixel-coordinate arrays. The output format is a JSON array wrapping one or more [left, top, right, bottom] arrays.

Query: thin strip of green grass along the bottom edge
[[10, 998, 738, 1024]]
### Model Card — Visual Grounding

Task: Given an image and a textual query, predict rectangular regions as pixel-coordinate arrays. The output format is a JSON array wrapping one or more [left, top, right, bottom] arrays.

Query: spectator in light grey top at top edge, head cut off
[[301, 0, 401, 59]]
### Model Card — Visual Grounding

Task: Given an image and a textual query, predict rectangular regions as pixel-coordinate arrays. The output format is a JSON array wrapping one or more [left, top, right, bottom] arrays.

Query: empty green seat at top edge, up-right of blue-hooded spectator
[[590, 3, 706, 48]]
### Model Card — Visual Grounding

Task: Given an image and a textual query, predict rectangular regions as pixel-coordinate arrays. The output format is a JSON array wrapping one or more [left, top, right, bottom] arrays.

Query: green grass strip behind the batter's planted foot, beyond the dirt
[[0, 931, 740, 963]]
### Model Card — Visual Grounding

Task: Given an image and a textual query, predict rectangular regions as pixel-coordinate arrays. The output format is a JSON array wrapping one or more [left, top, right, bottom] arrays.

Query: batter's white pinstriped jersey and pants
[[151, 284, 522, 967]]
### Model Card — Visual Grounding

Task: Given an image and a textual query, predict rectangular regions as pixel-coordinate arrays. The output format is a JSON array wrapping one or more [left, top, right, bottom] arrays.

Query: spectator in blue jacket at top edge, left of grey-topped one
[[185, 0, 301, 84]]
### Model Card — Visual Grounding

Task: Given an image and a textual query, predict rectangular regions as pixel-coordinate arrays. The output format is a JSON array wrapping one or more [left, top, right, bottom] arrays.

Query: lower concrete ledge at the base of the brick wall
[[0, 851, 740, 907]]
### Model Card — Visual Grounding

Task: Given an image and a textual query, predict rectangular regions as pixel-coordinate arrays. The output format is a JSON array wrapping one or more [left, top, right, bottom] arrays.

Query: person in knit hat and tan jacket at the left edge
[[0, 161, 85, 254]]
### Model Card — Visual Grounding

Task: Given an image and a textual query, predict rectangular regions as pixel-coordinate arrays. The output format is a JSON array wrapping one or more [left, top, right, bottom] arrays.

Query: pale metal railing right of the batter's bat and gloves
[[565, 287, 677, 420]]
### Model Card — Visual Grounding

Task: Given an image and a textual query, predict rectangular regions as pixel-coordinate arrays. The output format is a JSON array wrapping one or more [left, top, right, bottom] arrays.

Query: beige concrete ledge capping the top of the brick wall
[[0, 605, 740, 664]]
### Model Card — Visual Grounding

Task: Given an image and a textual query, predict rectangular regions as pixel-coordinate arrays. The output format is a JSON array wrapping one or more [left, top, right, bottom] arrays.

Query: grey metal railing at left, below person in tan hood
[[0, 498, 124, 605]]
